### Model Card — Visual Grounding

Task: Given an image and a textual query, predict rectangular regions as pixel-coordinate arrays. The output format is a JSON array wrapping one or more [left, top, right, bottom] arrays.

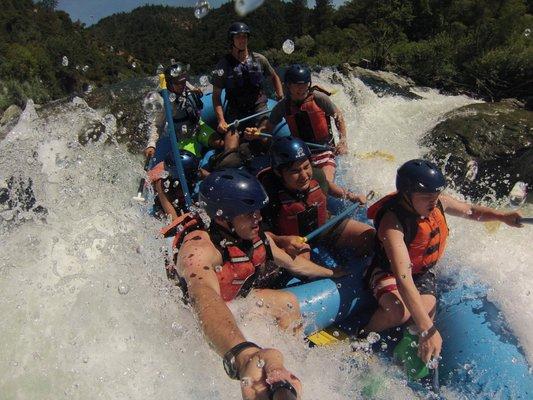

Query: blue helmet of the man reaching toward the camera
[[199, 168, 268, 220]]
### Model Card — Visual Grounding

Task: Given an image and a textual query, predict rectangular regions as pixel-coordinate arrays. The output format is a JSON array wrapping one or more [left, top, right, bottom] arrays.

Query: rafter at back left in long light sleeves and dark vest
[[144, 62, 219, 161]]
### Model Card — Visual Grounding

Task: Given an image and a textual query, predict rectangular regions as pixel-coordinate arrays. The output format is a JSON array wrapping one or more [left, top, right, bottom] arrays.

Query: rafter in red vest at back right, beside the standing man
[[245, 64, 348, 182]]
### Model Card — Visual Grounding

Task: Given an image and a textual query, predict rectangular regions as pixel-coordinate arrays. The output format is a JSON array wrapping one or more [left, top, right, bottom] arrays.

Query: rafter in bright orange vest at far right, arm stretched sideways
[[360, 160, 522, 363]]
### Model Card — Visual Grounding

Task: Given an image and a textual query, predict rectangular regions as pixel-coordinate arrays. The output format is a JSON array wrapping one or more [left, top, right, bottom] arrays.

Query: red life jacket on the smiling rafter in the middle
[[275, 179, 328, 236]]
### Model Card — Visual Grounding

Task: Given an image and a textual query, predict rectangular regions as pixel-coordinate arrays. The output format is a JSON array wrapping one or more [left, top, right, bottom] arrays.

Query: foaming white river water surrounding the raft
[[0, 71, 533, 400]]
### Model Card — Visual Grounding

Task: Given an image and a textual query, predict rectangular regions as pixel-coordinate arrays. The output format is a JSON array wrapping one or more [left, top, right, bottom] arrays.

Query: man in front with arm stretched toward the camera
[[170, 169, 348, 400]]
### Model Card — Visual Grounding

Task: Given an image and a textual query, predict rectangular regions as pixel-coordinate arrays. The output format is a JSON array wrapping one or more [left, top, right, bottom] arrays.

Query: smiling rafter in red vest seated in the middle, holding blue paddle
[[259, 136, 375, 256]]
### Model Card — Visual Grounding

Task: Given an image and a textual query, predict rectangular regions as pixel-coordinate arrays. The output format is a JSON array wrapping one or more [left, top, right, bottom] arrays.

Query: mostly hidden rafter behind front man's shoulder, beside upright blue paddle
[[148, 150, 200, 221]]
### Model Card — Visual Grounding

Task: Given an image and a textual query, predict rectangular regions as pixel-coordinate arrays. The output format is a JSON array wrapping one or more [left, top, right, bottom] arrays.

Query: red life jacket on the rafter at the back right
[[285, 93, 333, 144]]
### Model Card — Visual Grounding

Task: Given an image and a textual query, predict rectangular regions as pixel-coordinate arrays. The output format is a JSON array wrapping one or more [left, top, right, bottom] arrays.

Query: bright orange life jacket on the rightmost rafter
[[367, 193, 449, 275]]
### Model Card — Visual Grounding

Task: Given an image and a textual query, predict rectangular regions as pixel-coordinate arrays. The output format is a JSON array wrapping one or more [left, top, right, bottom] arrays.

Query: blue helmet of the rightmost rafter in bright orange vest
[[396, 160, 446, 193]]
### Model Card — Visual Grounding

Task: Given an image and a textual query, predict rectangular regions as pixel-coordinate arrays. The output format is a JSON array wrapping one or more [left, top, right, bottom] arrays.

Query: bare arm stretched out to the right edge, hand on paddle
[[439, 194, 523, 228]]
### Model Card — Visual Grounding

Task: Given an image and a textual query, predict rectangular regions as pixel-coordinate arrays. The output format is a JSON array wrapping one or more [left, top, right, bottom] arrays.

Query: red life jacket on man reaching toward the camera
[[164, 214, 281, 301]]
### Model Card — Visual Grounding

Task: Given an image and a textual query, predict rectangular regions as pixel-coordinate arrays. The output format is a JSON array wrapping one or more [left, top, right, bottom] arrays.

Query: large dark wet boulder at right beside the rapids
[[422, 101, 533, 199]]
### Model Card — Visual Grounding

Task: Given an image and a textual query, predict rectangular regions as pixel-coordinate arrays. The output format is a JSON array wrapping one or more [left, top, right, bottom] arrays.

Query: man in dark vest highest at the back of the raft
[[209, 22, 283, 169]]
